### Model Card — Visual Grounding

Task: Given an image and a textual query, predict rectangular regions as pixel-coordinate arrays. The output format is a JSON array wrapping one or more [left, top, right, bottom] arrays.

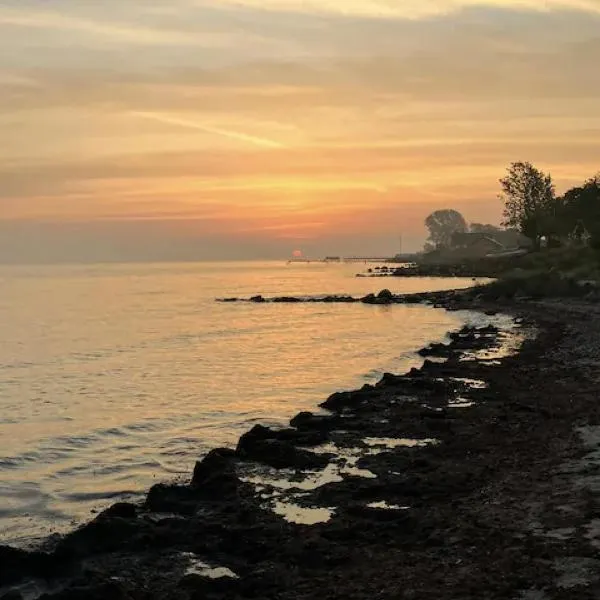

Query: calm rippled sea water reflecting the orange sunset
[[0, 263, 488, 543]]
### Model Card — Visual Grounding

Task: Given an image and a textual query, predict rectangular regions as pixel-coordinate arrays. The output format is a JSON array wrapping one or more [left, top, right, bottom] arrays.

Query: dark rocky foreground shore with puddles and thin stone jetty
[[0, 291, 600, 600]]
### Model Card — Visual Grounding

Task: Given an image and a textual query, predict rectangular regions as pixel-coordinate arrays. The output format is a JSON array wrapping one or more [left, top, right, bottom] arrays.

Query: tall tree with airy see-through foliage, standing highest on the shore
[[500, 162, 557, 248]]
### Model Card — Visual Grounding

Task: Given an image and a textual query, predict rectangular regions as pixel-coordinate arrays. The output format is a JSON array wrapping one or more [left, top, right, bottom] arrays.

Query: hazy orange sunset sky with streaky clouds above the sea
[[0, 0, 600, 263]]
